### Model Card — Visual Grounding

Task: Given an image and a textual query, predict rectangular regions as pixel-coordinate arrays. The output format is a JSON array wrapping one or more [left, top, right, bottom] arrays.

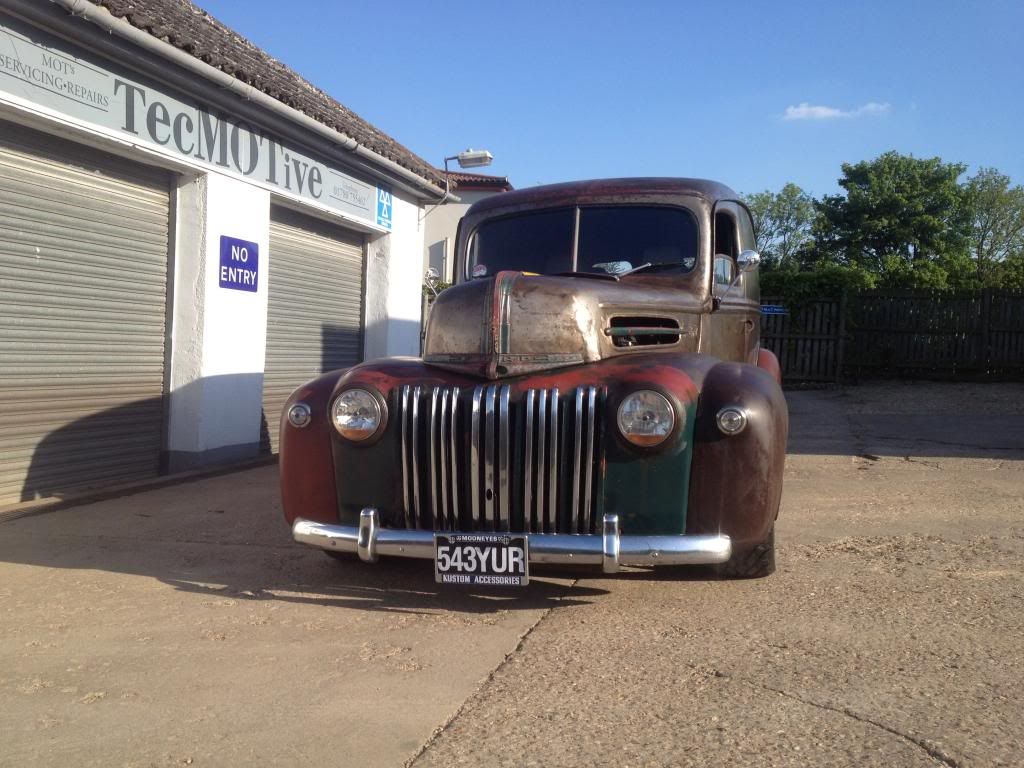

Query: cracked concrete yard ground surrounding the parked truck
[[0, 384, 1024, 768]]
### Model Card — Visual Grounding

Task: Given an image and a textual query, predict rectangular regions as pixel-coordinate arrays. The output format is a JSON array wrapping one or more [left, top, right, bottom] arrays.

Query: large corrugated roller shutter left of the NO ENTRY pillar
[[0, 122, 170, 505]]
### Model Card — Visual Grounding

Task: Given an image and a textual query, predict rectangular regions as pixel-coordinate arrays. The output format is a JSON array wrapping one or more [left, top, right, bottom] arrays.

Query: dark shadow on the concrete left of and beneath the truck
[[0, 481, 605, 613]]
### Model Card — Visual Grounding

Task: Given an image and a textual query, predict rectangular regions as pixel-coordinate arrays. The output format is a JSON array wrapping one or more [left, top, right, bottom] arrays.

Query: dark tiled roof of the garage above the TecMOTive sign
[[92, 0, 444, 184]]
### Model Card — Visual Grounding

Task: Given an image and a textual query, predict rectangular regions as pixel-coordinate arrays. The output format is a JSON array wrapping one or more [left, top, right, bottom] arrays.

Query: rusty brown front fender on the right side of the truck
[[686, 362, 790, 549]]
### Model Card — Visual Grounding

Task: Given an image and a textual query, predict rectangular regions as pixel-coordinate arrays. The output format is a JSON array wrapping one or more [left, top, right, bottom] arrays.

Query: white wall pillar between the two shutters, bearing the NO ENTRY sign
[[167, 173, 273, 469]]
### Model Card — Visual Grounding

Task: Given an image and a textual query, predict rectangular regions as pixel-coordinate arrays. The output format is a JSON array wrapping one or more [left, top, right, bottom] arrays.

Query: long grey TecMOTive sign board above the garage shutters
[[0, 15, 391, 228]]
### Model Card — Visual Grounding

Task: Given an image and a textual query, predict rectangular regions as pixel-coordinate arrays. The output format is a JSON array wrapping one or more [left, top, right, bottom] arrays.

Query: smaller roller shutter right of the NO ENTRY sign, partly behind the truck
[[262, 207, 366, 453]]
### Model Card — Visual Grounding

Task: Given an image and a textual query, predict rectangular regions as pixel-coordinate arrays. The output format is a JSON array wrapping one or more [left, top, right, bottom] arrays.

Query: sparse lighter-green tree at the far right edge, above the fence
[[965, 168, 1024, 286]]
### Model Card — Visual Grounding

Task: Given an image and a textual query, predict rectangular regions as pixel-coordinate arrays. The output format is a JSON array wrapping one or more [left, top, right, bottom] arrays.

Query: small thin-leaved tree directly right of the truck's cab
[[746, 181, 815, 269]]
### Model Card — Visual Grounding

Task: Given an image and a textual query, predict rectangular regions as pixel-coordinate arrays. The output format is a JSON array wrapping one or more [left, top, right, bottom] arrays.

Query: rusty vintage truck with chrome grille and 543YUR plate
[[281, 178, 788, 585]]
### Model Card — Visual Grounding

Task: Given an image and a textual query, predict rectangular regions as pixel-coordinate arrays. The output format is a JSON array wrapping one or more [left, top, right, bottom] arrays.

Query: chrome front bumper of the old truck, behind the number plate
[[292, 509, 732, 573]]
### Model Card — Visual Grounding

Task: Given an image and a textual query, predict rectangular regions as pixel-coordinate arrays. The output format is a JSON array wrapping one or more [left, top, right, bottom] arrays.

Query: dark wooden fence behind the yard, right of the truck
[[761, 290, 1024, 383]]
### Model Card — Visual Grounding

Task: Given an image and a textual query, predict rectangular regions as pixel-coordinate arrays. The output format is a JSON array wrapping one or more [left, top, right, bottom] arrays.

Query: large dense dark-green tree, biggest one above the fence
[[815, 152, 970, 288]]
